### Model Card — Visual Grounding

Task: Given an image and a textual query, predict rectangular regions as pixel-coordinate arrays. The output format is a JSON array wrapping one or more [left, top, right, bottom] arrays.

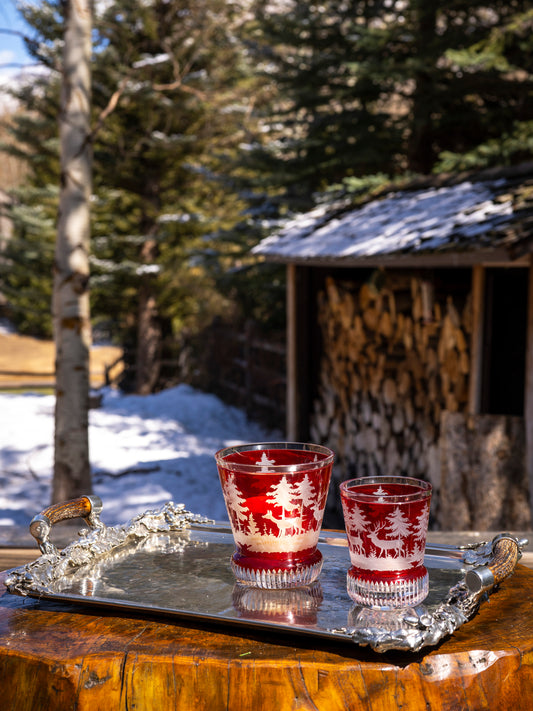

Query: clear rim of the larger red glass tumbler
[[215, 442, 335, 474]]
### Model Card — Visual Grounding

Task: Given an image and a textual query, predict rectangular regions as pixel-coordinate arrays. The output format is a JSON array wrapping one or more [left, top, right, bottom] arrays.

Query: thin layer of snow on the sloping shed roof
[[253, 170, 531, 262]]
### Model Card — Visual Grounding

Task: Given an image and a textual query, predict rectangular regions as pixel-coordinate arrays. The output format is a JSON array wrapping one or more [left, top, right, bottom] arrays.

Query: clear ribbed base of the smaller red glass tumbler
[[346, 571, 429, 608]]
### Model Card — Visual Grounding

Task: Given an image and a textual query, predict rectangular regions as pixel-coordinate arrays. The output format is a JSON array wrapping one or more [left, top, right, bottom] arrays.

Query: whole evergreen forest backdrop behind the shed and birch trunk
[[0, 0, 533, 428]]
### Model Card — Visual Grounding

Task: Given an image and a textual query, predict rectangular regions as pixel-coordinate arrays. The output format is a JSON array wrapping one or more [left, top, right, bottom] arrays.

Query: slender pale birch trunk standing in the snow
[[52, 0, 92, 503]]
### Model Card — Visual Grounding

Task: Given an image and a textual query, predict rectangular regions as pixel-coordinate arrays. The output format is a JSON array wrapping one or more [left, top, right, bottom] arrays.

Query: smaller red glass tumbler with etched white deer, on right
[[340, 476, 431, 608]]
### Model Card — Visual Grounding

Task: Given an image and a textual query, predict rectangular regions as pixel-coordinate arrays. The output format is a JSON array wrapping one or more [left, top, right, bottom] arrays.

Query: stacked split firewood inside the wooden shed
[[311, 273, 472, 524]]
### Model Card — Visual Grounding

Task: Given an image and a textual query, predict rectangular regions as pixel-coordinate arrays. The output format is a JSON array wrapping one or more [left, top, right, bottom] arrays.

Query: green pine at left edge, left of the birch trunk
[[0, 15, 62, 338]]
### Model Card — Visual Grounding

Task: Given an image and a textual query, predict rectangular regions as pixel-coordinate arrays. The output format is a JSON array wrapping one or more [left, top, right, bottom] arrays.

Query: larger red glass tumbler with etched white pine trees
[[215, 442, 334, 590]]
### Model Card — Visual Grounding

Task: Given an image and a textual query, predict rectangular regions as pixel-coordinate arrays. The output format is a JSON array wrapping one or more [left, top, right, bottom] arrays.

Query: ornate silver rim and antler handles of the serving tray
[[5, 497, 527, 652]]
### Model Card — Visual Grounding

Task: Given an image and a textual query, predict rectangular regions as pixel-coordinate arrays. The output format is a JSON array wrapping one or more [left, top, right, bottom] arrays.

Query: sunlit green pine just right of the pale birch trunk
[[90, 0, 262, 392]]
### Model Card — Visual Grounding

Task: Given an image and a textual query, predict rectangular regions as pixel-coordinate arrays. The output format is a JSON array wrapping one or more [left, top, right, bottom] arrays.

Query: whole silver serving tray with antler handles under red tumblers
[[6, 497, 527, 652]]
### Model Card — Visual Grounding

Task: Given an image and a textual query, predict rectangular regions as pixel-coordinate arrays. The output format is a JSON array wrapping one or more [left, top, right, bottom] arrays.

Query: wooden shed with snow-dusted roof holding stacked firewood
[[254, 164, 533, 530]]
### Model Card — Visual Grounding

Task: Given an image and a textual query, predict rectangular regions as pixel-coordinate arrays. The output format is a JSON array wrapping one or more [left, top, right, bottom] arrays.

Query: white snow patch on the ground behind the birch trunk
[[0, 385, 281, 532]]
